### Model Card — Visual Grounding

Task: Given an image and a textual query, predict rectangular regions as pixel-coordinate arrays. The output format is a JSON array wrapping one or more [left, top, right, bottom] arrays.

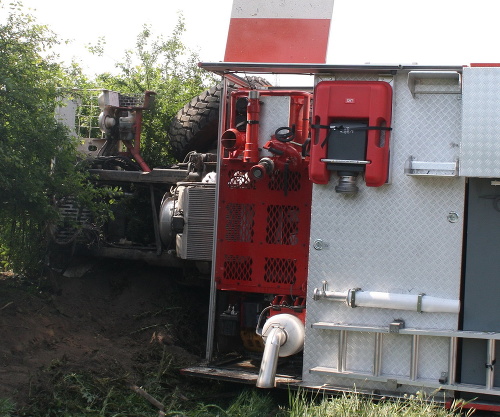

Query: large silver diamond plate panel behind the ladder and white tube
[[303, 71, 465, 391]]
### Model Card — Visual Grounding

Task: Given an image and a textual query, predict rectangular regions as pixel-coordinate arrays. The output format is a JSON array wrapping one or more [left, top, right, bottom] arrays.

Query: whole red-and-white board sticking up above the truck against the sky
[[224, 0, 333, 64]]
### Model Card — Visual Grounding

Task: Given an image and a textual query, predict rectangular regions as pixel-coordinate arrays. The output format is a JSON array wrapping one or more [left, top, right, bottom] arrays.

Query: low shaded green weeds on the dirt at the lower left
[[18, 345, 229, 417]]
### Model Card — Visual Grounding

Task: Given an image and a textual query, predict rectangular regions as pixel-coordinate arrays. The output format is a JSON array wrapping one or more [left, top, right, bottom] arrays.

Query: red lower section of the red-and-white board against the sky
[[224, 18, 330, 64]]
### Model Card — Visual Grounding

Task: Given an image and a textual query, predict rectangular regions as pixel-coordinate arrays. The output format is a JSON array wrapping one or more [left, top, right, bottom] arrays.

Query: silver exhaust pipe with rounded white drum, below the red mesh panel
[[256, 314, 305, 388]]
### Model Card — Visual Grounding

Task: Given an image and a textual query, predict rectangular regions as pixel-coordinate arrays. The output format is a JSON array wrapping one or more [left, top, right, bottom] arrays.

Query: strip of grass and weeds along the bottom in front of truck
[[0, 372, 472, 417]]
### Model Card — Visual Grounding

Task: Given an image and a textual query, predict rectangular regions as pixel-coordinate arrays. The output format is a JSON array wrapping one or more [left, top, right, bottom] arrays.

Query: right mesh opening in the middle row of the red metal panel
[[266, 205, 299, 245]]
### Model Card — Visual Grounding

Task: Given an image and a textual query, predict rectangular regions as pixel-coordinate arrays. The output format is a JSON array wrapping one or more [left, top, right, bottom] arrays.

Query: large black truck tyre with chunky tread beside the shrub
[[167, 77, 270, 162]]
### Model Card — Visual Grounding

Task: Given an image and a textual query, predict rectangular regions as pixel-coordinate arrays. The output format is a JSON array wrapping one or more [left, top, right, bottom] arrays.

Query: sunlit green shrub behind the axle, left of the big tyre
[[89, 15, 219, 167]]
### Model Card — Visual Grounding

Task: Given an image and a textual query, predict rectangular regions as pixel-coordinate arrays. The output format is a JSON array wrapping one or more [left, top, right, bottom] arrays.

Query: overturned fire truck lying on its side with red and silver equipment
[[58, 2, 500, 408]]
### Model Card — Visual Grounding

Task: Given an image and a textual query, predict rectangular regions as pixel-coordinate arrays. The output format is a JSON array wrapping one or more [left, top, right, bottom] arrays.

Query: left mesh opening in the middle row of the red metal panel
[[225, 203, 255, 243]]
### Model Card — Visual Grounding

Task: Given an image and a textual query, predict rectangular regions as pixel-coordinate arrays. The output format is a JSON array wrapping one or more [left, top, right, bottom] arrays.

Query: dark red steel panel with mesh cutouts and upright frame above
[[215, 90, 312, 296]]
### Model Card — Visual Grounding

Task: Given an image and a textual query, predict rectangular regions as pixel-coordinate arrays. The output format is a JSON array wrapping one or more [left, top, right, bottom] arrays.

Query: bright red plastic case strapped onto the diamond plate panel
[[309, 81, 392, 187]]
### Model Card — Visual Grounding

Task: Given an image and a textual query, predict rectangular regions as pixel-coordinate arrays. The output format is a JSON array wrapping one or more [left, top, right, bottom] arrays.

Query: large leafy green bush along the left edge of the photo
[[0, 0, 112, 274]]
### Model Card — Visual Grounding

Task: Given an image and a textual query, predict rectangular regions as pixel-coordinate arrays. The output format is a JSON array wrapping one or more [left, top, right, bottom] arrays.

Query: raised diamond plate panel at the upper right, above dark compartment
[[460, 67, 500, 177]]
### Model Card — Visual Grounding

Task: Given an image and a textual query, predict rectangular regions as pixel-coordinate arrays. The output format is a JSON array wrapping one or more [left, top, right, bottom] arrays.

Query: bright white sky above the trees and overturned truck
[[8, 0, 500, 74]]
